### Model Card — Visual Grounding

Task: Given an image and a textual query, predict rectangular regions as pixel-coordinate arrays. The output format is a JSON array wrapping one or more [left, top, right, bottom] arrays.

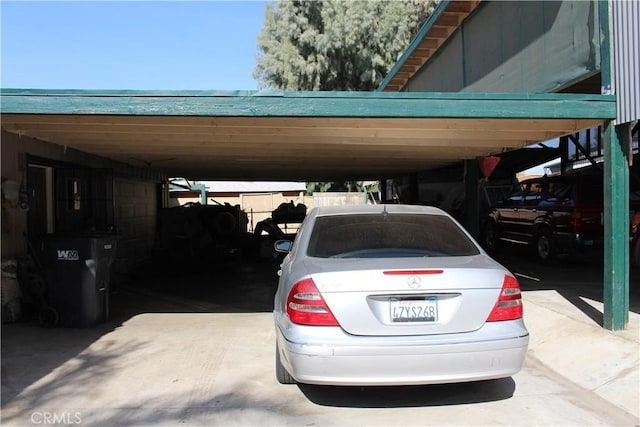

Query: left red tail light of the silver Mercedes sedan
[[287, 278, 339, 326]]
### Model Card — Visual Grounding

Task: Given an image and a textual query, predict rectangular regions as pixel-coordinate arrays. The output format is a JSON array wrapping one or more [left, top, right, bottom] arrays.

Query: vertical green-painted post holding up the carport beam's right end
[[603, 122, 629, 331]]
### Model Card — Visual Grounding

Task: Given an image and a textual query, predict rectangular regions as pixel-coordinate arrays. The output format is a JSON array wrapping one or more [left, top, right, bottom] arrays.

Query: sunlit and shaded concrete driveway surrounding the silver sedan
[[1, 254, 640, 426]]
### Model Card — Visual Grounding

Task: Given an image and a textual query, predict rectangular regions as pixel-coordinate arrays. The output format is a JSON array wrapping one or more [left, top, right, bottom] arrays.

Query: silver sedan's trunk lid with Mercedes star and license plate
[[305, 256, 507, 336]]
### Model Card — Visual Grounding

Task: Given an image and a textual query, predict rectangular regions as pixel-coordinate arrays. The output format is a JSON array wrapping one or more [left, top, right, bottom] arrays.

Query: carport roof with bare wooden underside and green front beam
[[0, 89, 615, 181]]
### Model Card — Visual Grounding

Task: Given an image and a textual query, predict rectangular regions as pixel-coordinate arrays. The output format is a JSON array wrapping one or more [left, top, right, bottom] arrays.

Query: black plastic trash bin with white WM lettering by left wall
[[41, 234, 117, 328]]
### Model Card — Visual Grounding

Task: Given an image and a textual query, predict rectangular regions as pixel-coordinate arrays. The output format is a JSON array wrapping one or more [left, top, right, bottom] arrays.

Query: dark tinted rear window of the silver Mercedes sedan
[[307, 213, 480, 258]]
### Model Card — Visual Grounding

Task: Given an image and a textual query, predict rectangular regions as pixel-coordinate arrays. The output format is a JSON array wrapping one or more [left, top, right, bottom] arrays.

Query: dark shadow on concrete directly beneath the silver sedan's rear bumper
[[298, 378, 516, 408]]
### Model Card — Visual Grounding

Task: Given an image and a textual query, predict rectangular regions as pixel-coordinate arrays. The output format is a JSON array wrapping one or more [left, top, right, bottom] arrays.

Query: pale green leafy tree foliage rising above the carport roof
[[254, 0, 437, 91]]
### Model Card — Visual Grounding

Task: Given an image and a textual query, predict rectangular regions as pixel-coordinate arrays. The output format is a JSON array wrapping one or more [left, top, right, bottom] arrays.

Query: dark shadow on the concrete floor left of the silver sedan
[[0, 263, 278, 412]]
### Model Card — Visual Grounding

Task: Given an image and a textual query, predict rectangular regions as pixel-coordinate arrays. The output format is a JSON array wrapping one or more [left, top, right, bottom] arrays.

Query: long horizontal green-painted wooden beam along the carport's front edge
[[0, 89, 615, 121]]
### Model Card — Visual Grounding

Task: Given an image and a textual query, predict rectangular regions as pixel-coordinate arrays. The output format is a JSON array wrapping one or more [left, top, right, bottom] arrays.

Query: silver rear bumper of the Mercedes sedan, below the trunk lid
[[277, 320, 529, 386]]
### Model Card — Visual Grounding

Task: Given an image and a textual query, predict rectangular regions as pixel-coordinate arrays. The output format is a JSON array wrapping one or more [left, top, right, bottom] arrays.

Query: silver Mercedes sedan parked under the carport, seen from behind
[[273, 205, 529, 385]]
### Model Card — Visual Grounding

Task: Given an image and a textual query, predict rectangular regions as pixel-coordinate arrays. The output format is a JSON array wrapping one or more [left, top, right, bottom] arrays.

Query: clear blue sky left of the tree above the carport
[[0, 0, 267, 90]]
